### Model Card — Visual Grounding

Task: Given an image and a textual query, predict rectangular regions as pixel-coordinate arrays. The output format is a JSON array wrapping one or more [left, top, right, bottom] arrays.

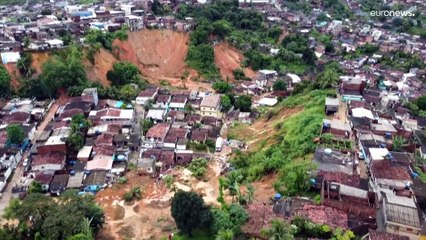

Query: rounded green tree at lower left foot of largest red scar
[[107, 62, 140, 86]]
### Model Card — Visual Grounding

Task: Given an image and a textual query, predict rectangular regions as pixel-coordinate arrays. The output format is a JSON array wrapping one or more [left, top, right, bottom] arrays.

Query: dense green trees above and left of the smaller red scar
[[177, 1, 282, 79]]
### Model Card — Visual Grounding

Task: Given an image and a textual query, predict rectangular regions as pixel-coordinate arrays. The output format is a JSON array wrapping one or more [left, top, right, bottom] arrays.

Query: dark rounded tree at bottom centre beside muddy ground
[[171, 191, 212, 237]]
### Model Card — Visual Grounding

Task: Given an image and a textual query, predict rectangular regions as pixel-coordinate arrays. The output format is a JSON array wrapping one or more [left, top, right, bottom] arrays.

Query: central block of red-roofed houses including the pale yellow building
[[136, 87, 236, 173]]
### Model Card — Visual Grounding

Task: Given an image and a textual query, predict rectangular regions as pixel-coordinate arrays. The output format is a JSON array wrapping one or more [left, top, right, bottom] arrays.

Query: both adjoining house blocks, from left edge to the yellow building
[[6, 87, 257, 195]]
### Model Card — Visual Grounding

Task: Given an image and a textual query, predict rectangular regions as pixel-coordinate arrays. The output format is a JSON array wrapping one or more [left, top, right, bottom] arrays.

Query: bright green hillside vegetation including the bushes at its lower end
[[230, 87, 333, 195]]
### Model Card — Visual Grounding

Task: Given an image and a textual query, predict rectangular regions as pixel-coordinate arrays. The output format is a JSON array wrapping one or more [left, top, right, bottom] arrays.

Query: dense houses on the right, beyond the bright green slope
[[266, 67, 426, 239]]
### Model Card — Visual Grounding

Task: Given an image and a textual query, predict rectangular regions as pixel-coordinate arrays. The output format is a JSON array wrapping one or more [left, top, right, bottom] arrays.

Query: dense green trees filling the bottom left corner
[[0, 191, 104, 239]]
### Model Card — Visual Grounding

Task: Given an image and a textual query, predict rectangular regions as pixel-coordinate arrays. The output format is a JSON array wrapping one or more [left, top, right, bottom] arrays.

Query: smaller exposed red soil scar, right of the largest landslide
[[214, 42, 256, 80]]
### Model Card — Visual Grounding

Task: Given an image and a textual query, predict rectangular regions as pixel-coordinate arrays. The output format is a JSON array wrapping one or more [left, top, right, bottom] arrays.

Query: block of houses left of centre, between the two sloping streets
[[7, 88, 139, 194]]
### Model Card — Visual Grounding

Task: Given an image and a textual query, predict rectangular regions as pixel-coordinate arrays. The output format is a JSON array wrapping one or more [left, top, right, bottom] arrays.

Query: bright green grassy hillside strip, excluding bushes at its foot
[[231, 90, 333, 180]]
